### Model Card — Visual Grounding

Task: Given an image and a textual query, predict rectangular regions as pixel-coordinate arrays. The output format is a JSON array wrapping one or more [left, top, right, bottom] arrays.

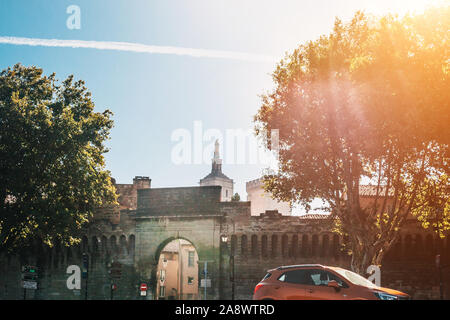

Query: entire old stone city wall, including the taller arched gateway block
[[0, 177, 450, 299]]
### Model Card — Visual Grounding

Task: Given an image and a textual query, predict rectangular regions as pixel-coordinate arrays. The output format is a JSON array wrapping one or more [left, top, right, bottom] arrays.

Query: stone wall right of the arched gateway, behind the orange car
[[224, 212, 450, 299]]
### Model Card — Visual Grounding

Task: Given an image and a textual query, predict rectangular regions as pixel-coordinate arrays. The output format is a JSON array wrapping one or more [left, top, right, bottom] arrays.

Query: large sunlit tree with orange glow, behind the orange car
[[255, 8, 450, 274]]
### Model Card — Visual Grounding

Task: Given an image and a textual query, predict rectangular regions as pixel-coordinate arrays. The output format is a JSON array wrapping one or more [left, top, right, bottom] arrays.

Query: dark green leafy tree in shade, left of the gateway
[[0, 64, 116, 252]]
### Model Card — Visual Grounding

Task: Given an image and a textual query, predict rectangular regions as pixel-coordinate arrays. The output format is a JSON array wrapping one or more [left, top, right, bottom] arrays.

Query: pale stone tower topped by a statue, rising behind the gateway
[[200, 140, 233, 201]]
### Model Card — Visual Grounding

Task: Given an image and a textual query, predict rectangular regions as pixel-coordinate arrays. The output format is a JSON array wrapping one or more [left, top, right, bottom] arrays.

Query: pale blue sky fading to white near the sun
[[0, 0, 442, 215]]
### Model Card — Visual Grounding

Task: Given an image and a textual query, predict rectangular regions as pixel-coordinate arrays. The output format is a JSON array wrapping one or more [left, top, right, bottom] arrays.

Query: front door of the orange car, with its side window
[[305, 269, 348, 300]]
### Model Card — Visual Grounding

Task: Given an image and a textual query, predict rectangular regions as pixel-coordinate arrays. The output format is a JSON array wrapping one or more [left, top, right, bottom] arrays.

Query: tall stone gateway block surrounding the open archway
[[135, 186, 232, 298]]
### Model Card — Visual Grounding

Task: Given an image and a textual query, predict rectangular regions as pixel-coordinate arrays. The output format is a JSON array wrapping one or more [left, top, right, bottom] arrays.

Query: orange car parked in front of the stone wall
[[253, 264, 410, 300]]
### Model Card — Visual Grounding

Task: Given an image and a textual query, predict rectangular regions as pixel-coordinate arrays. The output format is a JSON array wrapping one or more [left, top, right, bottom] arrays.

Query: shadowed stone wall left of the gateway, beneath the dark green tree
[[0, 225, 140, 300]]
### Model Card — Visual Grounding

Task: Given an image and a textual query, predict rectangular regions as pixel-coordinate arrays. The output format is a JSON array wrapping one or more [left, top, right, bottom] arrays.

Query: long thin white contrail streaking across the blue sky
[[0, 37, 277, 63]]
